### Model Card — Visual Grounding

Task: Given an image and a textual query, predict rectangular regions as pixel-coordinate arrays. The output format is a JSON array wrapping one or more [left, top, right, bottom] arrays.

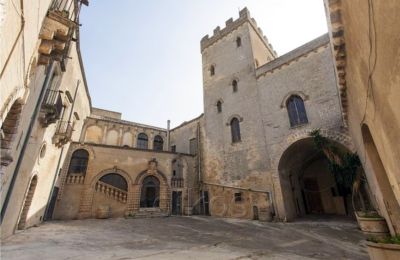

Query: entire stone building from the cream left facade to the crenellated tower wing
[[1, 0, 396, 240]]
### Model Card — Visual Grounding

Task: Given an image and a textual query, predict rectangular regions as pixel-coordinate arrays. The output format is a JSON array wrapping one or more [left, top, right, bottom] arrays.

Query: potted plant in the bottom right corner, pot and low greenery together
[[367, 236, 400, 260]]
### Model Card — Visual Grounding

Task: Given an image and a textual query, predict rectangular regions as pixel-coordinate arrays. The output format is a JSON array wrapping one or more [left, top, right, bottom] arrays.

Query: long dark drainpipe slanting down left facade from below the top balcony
[[0, 61, 54, 223]]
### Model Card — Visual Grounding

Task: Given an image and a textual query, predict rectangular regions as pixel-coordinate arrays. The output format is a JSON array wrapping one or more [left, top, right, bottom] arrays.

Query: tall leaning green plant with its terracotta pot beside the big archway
[[310, 129, 389, 238]]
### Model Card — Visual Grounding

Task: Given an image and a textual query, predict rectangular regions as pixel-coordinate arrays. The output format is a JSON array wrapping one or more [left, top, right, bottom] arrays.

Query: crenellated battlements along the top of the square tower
[[200, 7, 278, 57]]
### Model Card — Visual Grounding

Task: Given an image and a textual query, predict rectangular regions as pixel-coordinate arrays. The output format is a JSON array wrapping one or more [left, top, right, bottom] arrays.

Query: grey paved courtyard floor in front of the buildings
[[1, 217, 368, 260]]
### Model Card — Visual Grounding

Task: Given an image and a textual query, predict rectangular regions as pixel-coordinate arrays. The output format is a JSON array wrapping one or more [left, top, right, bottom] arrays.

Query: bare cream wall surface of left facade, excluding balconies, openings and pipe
[[0, 1, 90, 238]]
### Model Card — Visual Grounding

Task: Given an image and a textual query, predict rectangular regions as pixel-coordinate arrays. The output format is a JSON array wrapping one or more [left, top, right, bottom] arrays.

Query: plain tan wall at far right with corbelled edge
[[325, 0, 400, 234]]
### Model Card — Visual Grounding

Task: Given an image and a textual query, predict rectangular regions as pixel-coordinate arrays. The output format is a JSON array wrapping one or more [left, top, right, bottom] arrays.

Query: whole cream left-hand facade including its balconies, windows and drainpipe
[[0, 1, 91, 238]]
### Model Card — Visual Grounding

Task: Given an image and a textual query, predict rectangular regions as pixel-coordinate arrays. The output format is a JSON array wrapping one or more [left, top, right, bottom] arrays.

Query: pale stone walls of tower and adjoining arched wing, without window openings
[[202, 8, 348, 218]]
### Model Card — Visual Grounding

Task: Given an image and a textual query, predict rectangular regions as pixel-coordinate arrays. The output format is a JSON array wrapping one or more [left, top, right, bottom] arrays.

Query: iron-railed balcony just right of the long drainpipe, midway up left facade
[[39, 89, 63, 127]]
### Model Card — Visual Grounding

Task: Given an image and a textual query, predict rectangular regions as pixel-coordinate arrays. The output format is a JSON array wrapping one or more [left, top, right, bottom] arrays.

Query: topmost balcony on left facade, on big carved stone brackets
[[38, 0, 89, 71]]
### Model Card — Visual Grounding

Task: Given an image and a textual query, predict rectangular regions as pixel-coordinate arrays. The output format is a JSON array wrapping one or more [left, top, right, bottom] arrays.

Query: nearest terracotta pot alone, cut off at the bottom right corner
[[367, 242, 400, 260]]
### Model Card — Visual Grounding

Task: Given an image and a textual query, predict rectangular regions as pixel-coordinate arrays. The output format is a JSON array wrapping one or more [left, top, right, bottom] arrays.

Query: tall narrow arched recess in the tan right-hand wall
[[361, 124, 400, 234]]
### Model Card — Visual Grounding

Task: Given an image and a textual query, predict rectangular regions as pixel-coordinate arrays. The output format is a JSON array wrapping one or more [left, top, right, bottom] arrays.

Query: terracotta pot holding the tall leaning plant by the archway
[[356, 212, 389, 238]]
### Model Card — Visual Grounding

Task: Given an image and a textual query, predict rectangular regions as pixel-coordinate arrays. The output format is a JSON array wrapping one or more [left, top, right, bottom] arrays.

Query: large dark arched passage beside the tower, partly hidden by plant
[[278, 137, 353, 220]]
